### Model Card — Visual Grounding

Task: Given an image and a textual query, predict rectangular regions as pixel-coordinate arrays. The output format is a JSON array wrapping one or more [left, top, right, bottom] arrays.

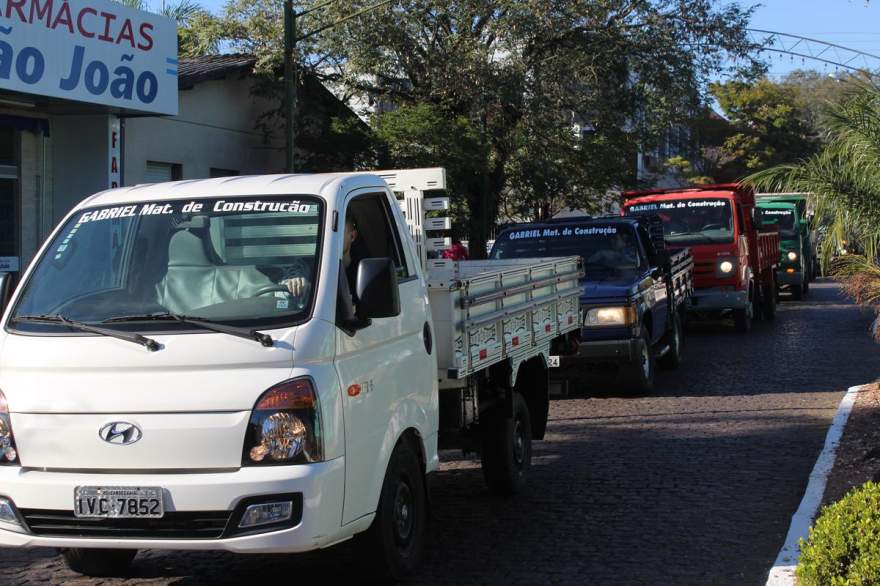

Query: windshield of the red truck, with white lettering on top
[[626, 198, 733, 246]]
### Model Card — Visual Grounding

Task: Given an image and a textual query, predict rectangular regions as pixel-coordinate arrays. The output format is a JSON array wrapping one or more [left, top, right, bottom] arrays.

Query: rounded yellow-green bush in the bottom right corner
[[797, 482, 880, 586]]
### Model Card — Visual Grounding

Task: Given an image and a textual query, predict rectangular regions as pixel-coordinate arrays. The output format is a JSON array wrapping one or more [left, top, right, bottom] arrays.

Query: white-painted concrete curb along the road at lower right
[[766, 385, 863, 586]]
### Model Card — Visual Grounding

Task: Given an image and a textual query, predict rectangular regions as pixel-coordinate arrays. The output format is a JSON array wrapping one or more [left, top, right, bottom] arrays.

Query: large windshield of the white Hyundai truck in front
[[12, 196, 322, 330]]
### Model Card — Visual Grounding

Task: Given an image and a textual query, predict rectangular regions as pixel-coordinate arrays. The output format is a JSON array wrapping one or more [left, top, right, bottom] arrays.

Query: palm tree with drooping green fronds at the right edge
[[745, 81, 880, 339]]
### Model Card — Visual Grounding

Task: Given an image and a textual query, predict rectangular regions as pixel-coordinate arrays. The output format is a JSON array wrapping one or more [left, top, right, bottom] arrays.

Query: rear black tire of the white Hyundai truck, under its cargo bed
[[480, 391, 532, 496]]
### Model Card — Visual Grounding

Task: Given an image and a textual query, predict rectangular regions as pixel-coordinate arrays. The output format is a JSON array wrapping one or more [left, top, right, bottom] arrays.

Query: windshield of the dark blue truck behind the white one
[[490, 224, 642, 270]]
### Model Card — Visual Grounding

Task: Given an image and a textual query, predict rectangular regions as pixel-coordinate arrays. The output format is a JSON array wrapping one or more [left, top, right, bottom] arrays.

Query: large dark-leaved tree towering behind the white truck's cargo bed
[[313, 0, 752, 254]]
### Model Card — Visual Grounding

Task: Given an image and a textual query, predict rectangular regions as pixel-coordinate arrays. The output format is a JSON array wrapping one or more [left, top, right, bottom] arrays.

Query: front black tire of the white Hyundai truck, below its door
[[357, 439, 428, 582]]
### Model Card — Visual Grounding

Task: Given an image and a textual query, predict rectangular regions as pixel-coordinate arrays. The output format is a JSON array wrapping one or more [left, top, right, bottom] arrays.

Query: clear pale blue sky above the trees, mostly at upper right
[[184, 0, 880, 79]]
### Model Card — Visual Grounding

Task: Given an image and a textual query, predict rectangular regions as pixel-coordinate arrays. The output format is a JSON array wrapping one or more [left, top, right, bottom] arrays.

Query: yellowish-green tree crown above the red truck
[[712, 78, 819, 178]]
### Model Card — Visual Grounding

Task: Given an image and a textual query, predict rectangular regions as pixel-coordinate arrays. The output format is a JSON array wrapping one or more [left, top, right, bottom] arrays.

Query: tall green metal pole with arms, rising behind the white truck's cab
[[284, 0, 393, 173]]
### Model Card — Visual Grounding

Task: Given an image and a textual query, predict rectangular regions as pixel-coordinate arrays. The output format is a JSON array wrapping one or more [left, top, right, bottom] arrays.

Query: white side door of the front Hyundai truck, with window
[[336, 190, 437, 523]]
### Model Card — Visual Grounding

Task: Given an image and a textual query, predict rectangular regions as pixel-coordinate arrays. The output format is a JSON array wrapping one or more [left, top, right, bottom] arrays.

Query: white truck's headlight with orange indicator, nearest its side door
[[242, 377, 324, 466]]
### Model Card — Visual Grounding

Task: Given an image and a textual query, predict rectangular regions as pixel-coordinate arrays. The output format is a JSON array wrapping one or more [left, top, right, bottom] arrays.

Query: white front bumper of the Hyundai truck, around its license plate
[[0, 458, 354, 553]]
